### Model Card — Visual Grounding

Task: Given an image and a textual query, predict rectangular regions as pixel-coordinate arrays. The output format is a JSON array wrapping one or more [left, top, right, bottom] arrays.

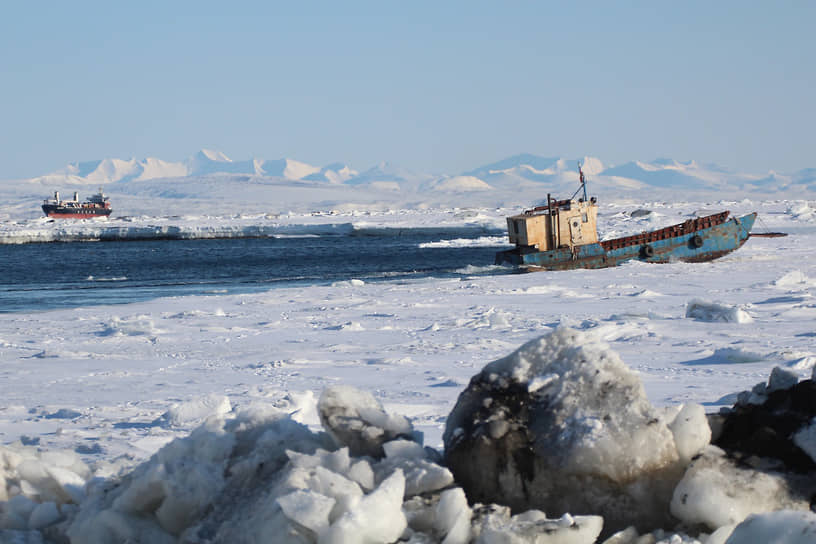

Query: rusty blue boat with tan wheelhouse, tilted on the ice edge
[[496, 167, 757, 270]]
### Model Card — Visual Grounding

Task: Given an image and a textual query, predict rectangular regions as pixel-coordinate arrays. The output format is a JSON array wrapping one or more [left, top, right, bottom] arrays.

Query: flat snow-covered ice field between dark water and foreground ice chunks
[[0, 178, 816, 540]]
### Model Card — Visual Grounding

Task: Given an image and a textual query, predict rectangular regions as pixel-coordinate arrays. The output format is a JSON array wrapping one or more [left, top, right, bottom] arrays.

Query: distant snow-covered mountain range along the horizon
[[30, 150, 816, 198]]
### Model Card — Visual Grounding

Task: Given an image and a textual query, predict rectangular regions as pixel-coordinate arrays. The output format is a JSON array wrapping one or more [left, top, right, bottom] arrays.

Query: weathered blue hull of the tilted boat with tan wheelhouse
[[496, 211, 757, 270]]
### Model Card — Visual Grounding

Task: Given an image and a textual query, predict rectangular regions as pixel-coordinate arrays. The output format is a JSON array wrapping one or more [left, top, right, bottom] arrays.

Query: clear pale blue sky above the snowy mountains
[[0, 0, 816, 179]]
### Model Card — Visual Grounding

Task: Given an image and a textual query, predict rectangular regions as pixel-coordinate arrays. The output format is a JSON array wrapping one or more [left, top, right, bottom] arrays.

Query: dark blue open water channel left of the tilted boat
[[0, 233, 510, 313]]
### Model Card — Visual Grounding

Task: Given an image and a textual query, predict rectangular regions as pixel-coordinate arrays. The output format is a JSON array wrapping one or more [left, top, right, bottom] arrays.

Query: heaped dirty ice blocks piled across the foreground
[[0, 327, 816, 544]]
